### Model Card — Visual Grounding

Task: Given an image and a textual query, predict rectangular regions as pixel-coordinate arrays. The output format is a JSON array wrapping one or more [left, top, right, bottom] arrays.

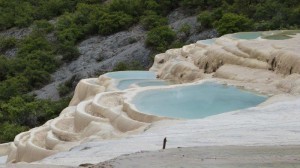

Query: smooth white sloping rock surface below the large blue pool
[[38, 99, 300, 166]]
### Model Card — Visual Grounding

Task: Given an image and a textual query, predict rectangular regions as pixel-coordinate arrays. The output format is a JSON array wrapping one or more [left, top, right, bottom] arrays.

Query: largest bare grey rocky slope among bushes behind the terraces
[[34, 26, 150, 100]]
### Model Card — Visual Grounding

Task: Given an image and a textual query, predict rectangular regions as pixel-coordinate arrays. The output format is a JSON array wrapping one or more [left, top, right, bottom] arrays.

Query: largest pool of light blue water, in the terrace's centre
[[132, 82, 267, 119]]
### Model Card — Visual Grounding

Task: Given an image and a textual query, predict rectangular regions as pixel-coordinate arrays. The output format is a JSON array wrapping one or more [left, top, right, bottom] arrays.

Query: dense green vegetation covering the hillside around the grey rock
[[0, 0, 300, 143]]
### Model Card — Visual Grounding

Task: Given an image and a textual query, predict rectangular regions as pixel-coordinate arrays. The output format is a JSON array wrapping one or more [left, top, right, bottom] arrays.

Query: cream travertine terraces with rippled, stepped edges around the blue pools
[[0, 30, 300, 163]]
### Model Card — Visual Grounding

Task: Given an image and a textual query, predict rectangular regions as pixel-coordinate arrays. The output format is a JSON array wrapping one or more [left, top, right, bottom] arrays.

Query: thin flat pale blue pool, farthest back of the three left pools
[[105, 71, 156, 79]]
